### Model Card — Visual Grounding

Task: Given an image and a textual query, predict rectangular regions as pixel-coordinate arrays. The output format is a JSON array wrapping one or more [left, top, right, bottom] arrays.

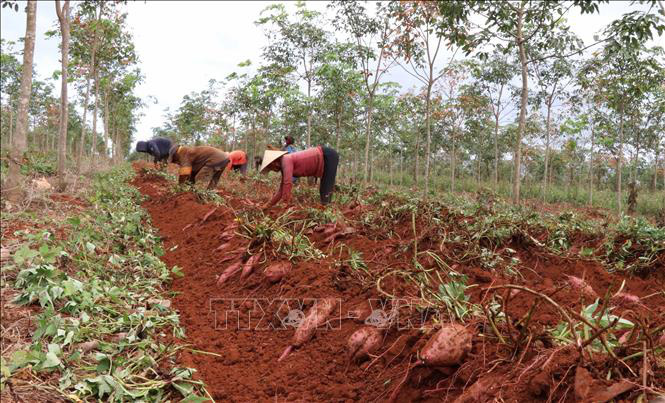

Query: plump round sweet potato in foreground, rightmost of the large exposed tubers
[[420, 323, 471, 367]]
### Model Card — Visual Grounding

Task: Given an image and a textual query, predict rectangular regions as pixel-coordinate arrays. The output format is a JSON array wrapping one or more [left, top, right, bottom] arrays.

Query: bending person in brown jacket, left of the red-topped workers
[[169, 145, 229, 189]]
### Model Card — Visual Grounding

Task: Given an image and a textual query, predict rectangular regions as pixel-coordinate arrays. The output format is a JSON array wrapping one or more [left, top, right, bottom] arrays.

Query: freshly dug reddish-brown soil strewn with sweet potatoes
[[133, 163, 665, 402]]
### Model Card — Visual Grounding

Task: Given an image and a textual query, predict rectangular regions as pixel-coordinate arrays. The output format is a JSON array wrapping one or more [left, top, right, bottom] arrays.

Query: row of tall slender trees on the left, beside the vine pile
[[1, 0, 143, 200]]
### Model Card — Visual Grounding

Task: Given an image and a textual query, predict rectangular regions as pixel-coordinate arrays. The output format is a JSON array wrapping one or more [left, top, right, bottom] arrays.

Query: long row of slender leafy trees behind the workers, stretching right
[[155, 1, 665, 213]]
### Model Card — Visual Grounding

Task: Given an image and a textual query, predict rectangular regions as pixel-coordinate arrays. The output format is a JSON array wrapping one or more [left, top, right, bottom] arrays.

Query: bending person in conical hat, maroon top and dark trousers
[[261, 146, 339, 208]]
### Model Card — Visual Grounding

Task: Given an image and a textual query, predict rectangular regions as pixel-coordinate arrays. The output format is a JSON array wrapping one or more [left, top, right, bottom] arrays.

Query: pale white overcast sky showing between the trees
[[0, 0, 665, 149]]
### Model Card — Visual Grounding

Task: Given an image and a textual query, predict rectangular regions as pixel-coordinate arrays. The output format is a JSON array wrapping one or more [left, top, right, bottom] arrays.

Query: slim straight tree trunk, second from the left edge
[[55, 0, 69, 192]]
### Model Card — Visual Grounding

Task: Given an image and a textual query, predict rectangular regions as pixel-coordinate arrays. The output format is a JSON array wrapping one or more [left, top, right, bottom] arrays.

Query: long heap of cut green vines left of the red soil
[[1, 166, 207, 401]]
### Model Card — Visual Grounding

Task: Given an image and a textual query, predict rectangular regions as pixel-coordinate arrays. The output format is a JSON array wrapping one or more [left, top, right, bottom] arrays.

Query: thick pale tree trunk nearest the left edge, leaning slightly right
[[3, 0, 37, 203]]
